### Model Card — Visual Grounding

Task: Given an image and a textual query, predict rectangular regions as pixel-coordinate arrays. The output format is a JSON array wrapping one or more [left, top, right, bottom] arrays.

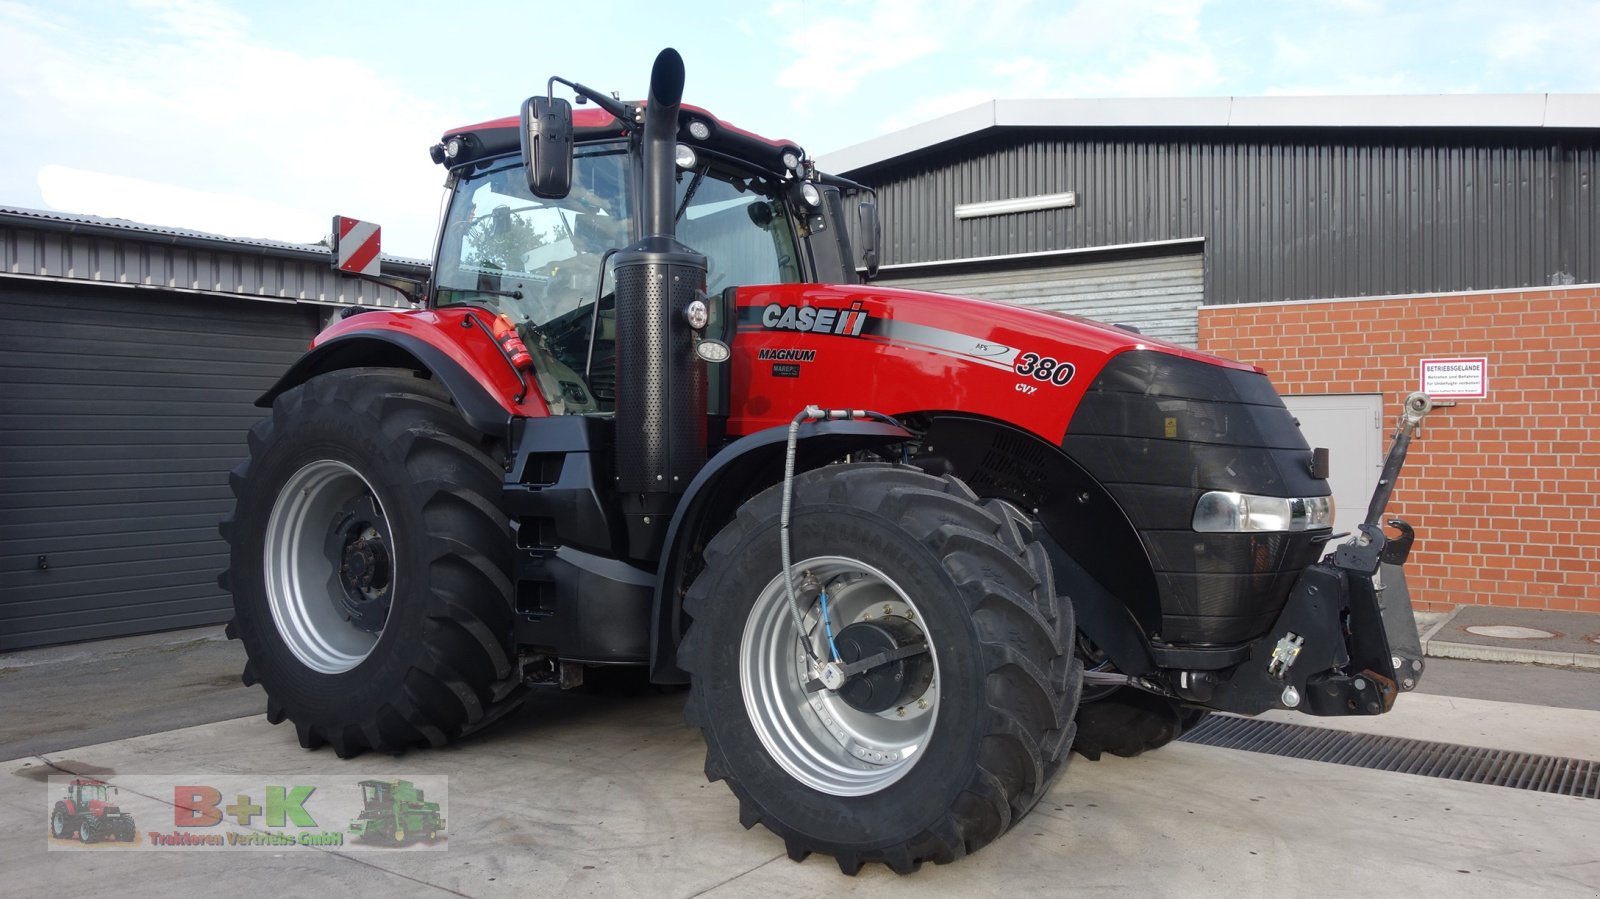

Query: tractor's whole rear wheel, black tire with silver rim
[[219, 368, 522, 758]]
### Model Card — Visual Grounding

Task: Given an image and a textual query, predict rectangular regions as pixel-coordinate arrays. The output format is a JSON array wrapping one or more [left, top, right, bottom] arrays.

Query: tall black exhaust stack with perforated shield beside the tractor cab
[[614, 48, 707, 560]]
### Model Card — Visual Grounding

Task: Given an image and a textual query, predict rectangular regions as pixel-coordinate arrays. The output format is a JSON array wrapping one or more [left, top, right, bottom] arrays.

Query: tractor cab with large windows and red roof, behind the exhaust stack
[[432, 107, 858, 414]]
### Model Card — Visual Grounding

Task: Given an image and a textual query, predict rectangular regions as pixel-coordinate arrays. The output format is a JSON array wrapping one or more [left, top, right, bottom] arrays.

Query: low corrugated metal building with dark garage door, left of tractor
[[0, 208, 427, 651]]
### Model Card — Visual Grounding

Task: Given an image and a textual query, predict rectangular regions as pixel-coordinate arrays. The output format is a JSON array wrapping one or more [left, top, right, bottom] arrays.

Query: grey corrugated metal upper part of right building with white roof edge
[[821, 94, 1600, 344]]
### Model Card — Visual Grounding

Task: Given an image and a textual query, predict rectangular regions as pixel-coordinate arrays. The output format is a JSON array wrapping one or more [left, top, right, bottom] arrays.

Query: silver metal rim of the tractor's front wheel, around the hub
[[739, 555, 939, 797]]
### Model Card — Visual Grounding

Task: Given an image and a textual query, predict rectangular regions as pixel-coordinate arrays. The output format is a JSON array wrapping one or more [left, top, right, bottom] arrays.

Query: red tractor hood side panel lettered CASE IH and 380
[[728, 285, 1264, 445]]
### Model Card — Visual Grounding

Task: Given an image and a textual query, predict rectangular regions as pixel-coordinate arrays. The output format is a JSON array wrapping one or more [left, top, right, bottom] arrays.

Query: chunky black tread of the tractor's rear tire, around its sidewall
[[219, 368, 523, 758]]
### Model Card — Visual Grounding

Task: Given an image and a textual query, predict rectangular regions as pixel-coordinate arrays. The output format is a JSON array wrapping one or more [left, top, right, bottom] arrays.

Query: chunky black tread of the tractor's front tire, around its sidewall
[[678, 464, 1082, 875]]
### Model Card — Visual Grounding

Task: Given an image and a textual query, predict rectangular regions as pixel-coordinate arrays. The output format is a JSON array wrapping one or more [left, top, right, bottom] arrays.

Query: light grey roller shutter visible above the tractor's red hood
[[877, 253, 1205, 347]]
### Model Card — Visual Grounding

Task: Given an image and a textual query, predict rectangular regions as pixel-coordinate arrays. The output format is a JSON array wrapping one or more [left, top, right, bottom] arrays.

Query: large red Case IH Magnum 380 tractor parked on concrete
[[222, 50, 1427, 873]]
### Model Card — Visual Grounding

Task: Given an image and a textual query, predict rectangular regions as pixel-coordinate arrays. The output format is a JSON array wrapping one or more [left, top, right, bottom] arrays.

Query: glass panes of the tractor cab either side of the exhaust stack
[[435, 142, 802, 414]]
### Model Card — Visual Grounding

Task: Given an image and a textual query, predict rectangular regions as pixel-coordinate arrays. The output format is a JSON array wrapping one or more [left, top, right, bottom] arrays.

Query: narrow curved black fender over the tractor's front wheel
[[650, 421, 912, 683]]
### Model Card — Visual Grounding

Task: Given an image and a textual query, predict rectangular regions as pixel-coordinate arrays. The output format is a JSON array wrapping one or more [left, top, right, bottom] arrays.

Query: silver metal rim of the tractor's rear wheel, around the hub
[[262, 459, 398, 673]]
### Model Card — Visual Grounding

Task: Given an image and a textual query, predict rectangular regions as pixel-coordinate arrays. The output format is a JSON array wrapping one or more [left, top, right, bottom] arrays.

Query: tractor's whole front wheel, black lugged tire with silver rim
[[680, 464, 1082, 873]]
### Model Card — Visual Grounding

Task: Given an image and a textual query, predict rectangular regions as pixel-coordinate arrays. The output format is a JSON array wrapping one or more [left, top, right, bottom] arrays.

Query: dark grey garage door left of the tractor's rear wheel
[[0, 282, 317, 651]]
